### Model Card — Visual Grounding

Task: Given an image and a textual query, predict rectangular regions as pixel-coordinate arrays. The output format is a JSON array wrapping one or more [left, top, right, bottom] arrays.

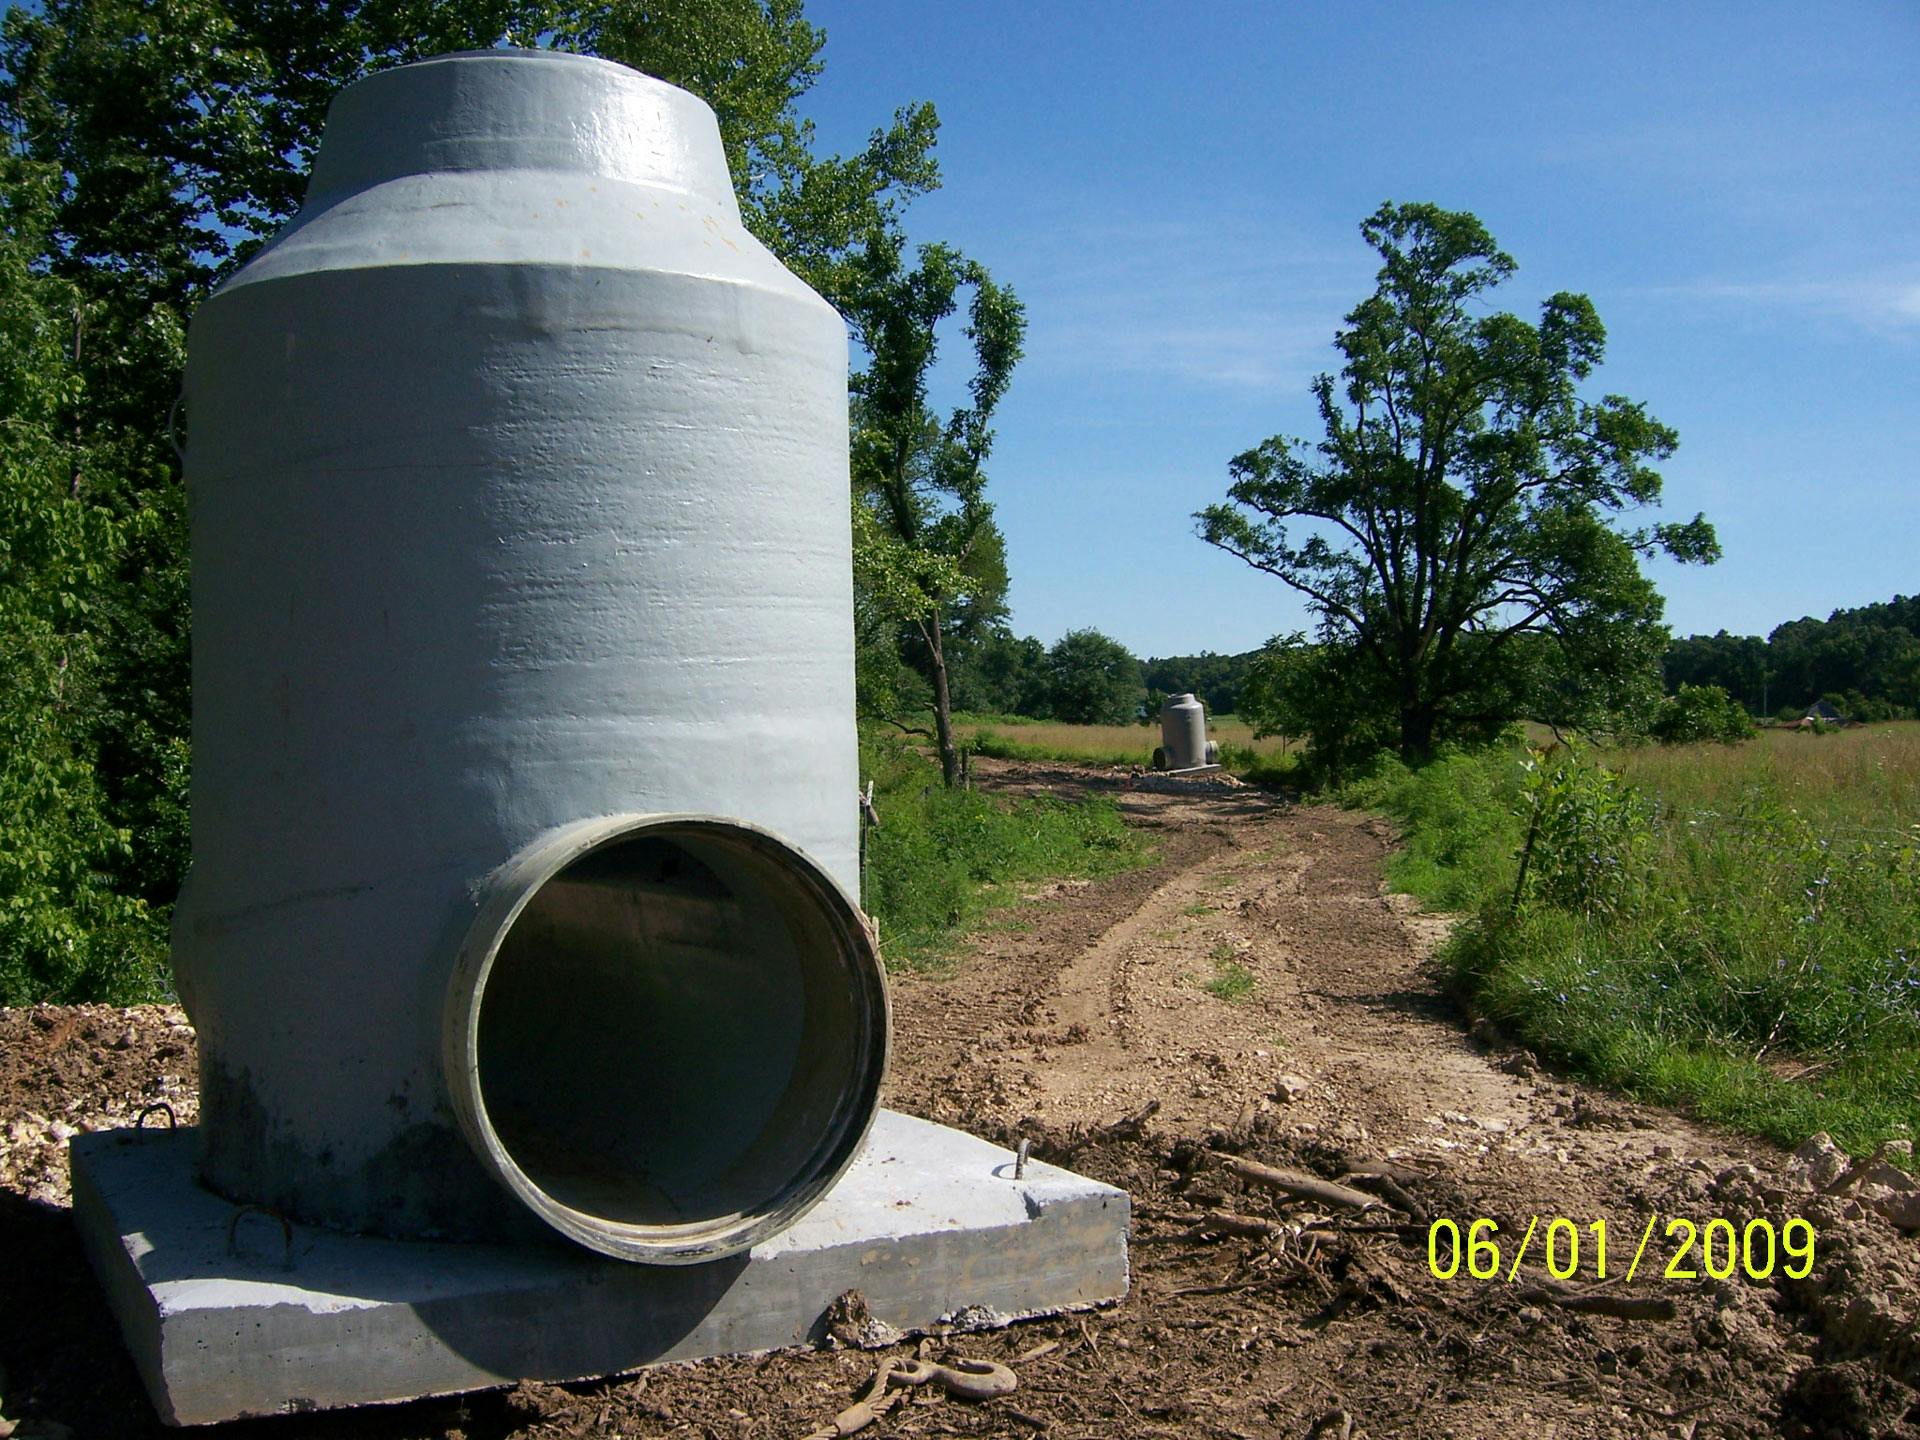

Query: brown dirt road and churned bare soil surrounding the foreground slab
[[0, 760, 1920, 1440]]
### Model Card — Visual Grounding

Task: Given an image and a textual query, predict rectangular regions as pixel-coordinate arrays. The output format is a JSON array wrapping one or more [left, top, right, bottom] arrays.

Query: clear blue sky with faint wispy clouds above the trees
[[806, 0, 1920, 655]]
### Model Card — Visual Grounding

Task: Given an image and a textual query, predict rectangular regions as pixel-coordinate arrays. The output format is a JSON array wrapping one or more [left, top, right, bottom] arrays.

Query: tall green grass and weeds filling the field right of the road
[[1348, 724, 1920, 1150]]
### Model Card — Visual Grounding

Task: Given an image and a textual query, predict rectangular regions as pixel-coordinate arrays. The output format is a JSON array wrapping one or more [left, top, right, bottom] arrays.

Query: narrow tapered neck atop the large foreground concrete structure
[[307, 50, 739, 217]]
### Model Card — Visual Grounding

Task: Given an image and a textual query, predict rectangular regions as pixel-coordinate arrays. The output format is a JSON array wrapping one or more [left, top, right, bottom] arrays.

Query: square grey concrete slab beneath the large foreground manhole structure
[[73, 1110, 1129, 1425]]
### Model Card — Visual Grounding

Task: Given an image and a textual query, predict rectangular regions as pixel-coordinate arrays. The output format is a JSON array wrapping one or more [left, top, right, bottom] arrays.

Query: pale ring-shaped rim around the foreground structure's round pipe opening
[[442, 812, 893, 1265]]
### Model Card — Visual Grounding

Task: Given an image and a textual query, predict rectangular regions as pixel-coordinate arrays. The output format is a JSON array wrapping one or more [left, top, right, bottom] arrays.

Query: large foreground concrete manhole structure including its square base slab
[[71, 52, 1127, 1425]]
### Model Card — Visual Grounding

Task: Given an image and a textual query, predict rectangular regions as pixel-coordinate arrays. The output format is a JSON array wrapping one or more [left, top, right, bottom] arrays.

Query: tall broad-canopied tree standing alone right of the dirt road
[[1194, 204, 1718, 766]]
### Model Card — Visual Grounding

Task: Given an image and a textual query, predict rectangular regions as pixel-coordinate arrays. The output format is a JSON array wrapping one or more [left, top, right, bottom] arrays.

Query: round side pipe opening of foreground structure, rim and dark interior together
[[447, 816, 887, 1263]]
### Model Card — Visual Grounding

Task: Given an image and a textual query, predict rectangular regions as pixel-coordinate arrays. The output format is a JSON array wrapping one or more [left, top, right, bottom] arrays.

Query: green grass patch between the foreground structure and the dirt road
[[860, 737, 1152, 968]]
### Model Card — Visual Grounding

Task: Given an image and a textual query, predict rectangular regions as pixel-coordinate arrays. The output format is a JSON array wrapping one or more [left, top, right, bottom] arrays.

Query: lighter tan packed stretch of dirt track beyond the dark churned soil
[[895, 768, 1530, 1154]]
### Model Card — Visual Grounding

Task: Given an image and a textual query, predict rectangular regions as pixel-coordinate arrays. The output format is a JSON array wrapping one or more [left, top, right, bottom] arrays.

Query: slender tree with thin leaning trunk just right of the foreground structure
[[843, 228, 1027, 787]]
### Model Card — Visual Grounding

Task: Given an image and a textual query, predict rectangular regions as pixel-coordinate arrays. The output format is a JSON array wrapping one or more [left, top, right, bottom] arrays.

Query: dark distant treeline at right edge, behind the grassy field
[[1665, 595, 1920, 720]]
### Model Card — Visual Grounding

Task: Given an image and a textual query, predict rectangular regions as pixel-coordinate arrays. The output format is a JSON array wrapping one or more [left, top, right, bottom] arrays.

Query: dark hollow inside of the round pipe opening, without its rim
[[478, 826, 874, 1227]]
